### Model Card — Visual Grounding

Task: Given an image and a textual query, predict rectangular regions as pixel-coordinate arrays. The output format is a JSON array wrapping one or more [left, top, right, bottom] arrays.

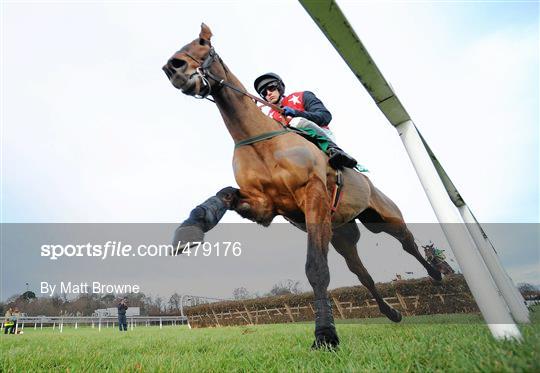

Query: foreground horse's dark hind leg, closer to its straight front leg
[[332, 222, 402, 322]]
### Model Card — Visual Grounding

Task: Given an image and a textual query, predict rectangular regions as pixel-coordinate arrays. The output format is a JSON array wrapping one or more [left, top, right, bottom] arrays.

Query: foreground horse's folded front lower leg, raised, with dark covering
[[173, 187, 238, 254]]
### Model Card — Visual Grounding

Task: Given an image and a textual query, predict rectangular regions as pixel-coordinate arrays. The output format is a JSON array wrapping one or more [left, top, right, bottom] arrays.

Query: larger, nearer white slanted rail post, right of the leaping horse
[[396, 120, 521, 340]]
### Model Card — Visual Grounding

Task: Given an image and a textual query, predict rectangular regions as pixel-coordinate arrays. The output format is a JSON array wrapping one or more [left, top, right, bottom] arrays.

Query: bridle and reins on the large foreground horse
[[182, 47, 283, 113]]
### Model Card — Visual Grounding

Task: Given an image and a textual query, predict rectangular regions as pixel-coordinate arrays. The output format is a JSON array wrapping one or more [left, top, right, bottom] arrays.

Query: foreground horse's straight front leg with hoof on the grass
[[304, 178, 339, 348]]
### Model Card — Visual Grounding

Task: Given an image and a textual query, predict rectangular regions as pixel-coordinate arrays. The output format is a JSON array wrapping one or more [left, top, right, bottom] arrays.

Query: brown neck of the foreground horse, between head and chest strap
[[213, 67, 281, 143]]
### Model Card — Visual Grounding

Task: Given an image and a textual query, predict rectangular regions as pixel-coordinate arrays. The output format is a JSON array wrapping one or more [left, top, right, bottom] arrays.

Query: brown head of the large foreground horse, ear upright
[[163, 23, 219, 97]]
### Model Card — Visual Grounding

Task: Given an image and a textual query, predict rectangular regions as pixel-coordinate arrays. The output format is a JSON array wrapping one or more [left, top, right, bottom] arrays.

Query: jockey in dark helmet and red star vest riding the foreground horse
[[254, 73, 357, 169]]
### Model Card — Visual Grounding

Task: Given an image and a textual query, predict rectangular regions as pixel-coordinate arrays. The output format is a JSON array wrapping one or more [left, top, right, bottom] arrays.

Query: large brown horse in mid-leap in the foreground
[[162, 23, 442, 349]]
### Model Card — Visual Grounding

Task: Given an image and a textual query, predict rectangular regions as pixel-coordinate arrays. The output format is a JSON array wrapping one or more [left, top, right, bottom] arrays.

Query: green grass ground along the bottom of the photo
[[0, 309, 540, 372]]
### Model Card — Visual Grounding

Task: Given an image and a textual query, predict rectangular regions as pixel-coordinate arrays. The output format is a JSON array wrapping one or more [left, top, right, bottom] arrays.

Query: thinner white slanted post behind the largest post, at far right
[[458, 205, 531, 323]]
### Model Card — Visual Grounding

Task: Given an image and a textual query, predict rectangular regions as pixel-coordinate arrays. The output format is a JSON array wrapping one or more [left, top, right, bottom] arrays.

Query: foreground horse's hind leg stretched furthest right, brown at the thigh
[[358, 187, 442, 281]]
